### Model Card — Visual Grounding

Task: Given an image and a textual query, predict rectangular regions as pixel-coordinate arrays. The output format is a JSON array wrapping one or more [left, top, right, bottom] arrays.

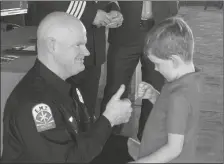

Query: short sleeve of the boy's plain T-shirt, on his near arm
[[167, 95, 189, 134]]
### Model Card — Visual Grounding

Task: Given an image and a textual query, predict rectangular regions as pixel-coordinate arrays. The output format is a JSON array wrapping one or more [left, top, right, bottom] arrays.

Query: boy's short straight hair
[[144, 17, 194, 62]]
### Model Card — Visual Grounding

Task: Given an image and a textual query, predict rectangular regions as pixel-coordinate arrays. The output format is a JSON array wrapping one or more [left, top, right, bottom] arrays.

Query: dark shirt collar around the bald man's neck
[[34, 59, 71, 96]]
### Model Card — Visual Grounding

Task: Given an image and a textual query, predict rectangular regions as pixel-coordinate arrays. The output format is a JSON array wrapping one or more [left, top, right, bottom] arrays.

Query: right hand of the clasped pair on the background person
[[106, 10, 124, 28]]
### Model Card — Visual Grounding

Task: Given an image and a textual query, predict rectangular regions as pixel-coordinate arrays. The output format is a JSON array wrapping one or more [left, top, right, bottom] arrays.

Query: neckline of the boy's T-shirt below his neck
[[167, 67, 201, 90]]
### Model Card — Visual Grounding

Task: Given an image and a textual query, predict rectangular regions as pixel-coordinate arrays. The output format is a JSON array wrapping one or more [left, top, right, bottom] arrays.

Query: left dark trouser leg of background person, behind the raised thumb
[[101, 46, 140, 134]]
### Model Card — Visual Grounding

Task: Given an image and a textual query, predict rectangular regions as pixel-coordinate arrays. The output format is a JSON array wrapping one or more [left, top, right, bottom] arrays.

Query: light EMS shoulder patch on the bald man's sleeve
[[32, 103, 56, 132]]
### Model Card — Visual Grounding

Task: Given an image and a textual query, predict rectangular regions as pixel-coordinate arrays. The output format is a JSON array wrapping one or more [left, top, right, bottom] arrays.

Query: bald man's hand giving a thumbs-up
[[103, 85, 133, 126]]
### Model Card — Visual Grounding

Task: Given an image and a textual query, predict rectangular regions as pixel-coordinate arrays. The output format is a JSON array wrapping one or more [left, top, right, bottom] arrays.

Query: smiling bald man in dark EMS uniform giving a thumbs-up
[[2, 12, 132, 163]]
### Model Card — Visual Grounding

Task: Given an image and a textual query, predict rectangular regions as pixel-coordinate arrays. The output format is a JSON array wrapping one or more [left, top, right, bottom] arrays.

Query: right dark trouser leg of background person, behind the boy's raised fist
[[137, 55, 164, 141]]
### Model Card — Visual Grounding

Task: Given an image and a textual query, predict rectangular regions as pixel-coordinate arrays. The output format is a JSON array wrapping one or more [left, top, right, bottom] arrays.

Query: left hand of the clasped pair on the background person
[[93, 10, 111, 27]]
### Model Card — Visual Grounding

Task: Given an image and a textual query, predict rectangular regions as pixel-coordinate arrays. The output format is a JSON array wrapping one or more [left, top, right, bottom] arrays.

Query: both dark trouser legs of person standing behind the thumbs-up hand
[[101, 45, 164, 139]]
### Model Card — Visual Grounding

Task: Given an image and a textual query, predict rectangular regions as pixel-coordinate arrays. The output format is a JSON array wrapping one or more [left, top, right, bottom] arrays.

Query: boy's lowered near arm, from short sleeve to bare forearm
[[134, 96, 189, 163]]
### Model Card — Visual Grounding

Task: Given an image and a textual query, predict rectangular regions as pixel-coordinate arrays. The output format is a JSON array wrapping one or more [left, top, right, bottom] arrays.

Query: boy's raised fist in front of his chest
[[138, 82, 159, 104]]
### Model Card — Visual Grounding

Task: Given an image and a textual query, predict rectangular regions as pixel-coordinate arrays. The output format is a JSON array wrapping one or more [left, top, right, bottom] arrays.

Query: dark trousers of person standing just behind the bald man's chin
[[67, 65, 101, 116]]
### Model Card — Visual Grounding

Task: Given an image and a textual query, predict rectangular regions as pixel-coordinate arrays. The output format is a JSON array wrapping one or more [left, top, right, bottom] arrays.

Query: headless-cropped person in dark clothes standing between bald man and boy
[[101, 1, 178, 140]]
